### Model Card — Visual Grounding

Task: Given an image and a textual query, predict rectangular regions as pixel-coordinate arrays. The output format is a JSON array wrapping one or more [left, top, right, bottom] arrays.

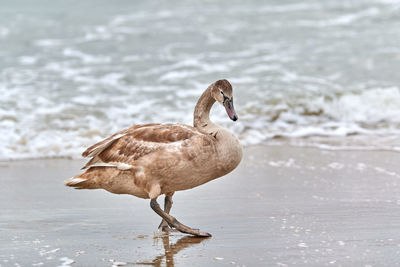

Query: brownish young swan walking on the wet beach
[[64, 80, 242, 237]]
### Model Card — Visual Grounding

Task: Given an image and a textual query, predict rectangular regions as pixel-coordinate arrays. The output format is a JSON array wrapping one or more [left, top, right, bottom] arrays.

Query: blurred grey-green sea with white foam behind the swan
[[0, 0, 400, 159]]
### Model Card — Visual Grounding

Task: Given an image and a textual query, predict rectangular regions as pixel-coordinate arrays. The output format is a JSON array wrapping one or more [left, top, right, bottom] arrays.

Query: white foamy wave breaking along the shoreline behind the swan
[[0, 87, 400, 159]]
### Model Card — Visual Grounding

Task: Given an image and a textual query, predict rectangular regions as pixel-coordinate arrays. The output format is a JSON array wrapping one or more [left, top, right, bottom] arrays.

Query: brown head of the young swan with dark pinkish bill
[[211, 79, 238, 121]]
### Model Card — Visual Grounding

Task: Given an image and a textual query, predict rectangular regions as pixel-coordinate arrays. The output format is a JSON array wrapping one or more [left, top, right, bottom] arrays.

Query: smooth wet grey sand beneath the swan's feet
[[0, 146, 400, 266]]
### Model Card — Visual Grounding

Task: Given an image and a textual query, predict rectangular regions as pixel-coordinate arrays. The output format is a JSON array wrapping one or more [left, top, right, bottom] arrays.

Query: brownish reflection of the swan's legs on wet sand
[[136, 235, 207, 267]]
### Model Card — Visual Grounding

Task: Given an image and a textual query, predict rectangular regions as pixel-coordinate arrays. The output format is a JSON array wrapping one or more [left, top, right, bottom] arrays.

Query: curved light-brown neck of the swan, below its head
[[193, 85, 215, 128]]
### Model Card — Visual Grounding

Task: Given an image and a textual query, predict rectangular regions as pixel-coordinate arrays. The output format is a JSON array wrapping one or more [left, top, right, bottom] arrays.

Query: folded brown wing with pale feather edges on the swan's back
[[82, 124, 209, 169]]
